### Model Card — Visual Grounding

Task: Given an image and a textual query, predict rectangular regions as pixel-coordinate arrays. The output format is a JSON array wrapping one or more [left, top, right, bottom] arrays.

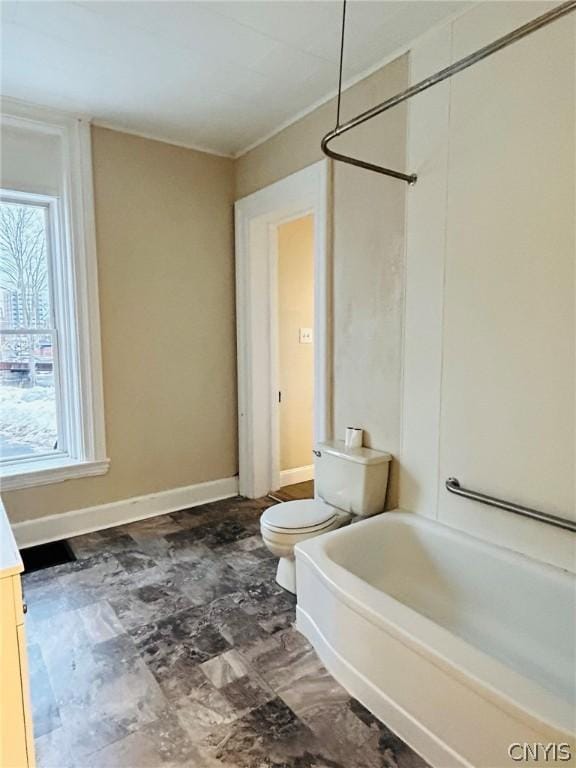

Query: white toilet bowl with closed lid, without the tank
[[260, 499, 350, 594]]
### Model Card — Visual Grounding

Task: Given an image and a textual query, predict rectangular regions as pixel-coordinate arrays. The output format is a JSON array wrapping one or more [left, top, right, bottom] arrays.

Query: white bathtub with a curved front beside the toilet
[[296, 511, 576, 768]]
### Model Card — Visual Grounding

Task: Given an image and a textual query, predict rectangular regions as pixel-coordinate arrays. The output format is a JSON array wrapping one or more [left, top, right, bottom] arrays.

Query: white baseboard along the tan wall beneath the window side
[[12, 477, 238, 548]]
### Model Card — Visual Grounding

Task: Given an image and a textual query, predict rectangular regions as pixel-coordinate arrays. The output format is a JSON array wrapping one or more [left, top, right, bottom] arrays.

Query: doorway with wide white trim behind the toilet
[[235, 161, 330, 498]]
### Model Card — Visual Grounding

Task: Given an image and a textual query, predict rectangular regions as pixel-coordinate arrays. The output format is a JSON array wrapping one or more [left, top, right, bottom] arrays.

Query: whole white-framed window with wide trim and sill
[[0, 105, 109, 490]]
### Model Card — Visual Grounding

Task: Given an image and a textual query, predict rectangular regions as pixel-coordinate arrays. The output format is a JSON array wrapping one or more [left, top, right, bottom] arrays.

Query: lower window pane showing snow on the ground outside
[[0, 333, 58, 460]]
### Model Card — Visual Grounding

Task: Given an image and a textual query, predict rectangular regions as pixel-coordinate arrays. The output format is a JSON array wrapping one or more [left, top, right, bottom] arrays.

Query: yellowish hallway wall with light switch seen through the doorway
[[278, 215, 314, 470]]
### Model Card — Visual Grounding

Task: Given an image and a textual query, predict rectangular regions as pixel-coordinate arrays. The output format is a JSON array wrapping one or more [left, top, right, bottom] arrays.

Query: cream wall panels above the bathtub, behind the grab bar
[[400, 2, 576, 568]]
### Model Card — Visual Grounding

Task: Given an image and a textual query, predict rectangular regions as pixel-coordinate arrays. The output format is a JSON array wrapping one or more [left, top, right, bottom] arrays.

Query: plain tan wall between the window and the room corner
[[3, 128, 237, 521]]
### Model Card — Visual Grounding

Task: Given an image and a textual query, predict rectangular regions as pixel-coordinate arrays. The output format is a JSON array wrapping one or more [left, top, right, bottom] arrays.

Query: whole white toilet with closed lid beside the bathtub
[[260, 440, 392, 594]]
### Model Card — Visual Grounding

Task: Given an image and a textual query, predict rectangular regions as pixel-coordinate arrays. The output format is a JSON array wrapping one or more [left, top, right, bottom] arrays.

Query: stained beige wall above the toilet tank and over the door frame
[[236, 56, 408, 506]]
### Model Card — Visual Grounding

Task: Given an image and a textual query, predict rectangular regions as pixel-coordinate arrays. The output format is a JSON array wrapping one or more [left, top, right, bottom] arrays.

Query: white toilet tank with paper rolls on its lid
[[314, 440, 392, 517]]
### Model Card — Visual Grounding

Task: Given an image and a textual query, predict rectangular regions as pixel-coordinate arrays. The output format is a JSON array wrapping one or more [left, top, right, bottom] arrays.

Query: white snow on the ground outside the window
[[0, 385, 57, 451]]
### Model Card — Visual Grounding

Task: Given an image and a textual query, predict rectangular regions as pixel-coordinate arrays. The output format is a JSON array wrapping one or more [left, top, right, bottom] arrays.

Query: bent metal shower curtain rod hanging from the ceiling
[[321, 0, 576, 184]]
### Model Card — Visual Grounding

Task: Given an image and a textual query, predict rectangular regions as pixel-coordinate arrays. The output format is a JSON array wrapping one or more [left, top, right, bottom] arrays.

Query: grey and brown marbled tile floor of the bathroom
[[24, 498, 425, 768]]
